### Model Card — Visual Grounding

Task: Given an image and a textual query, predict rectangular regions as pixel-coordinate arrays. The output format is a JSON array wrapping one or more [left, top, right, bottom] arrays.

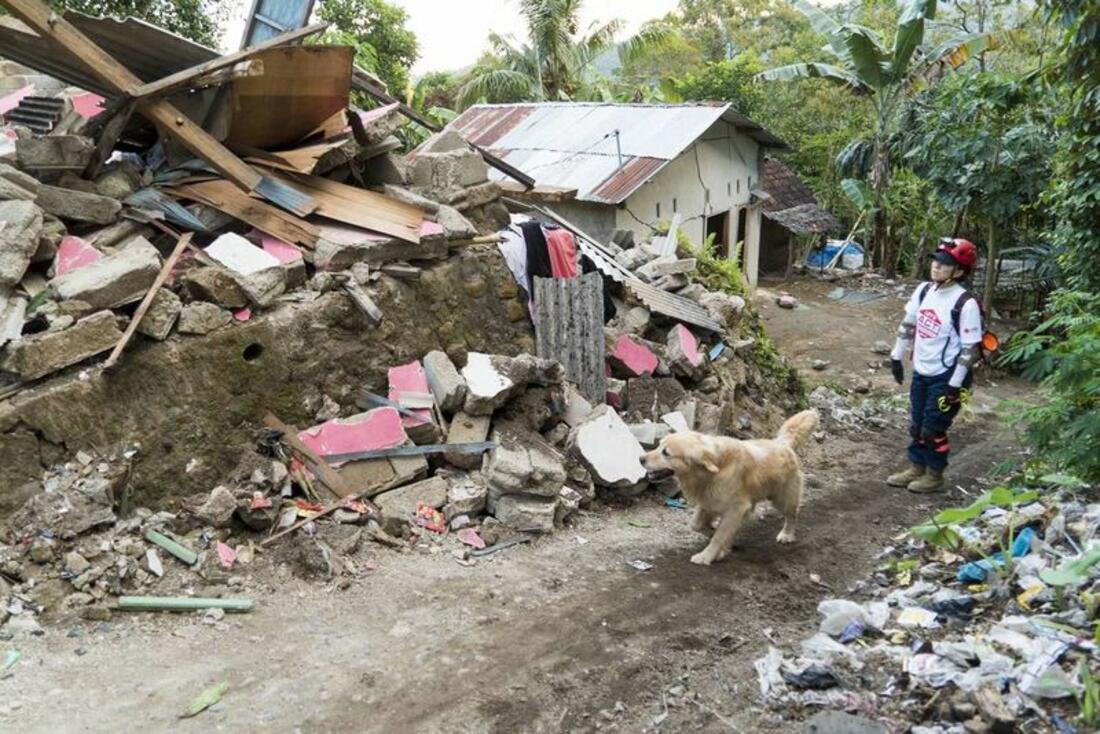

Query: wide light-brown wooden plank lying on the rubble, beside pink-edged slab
[[255, 172, 424, 243]]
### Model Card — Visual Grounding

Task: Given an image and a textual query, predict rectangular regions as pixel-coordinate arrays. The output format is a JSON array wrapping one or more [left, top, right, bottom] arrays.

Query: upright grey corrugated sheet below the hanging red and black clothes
[[535, 273, 607, 405]]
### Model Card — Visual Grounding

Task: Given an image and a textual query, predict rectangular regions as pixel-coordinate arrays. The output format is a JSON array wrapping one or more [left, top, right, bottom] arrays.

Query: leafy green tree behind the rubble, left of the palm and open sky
[[319, 0, 419, 97]]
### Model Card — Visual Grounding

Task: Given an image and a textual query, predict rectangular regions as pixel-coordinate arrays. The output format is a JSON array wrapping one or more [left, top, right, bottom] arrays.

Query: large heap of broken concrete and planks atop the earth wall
[[0, 15, 517, 392]]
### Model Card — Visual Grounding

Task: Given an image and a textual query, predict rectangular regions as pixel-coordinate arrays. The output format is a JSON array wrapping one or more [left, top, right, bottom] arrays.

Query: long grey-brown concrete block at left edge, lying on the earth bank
[[0, 310, 122, 380]]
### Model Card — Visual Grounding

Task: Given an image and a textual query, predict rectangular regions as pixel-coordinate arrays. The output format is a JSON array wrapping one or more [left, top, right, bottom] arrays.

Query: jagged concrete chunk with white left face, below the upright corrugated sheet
[[462, 352, 563, 415]]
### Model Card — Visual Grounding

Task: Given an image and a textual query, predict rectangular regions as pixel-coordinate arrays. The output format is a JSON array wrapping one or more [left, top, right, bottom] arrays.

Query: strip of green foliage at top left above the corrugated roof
[[56, 0, 229, 47]]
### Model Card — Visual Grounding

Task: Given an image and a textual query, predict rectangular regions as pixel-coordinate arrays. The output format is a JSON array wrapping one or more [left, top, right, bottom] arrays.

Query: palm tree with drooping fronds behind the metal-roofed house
[[458, 0, 670, 109]]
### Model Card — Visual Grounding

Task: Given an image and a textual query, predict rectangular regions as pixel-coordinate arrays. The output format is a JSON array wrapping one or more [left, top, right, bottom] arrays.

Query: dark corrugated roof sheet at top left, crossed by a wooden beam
[[0, 10, 219, 96]]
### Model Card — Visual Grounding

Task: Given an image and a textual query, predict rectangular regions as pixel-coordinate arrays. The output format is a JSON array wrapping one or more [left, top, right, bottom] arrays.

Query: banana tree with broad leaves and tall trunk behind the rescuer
[[757, 0, 992, 275]]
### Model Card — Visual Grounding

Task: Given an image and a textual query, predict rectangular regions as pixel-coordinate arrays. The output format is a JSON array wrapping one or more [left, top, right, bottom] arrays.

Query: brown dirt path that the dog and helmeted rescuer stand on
[[0, 274, 1025, 734]]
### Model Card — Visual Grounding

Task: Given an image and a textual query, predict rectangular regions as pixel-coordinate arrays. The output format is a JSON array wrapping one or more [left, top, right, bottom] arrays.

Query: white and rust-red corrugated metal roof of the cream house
[[449, 102, 787, 204]]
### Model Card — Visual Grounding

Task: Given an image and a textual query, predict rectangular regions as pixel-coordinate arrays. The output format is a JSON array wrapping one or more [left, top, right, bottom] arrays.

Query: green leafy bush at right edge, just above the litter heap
[[1000, 291, 1100, 482]]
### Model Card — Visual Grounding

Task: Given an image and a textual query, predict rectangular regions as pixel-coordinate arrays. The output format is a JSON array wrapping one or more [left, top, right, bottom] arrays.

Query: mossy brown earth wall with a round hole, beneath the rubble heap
[[0, 245, 535, 512]]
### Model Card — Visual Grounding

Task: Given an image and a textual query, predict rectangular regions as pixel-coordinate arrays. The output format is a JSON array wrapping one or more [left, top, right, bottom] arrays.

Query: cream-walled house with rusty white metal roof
[[449, 102, 785, 284]]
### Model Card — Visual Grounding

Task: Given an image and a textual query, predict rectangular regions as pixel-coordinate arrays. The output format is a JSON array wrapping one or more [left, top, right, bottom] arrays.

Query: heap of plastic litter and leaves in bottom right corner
[[755, 475, 1100, 734]]
